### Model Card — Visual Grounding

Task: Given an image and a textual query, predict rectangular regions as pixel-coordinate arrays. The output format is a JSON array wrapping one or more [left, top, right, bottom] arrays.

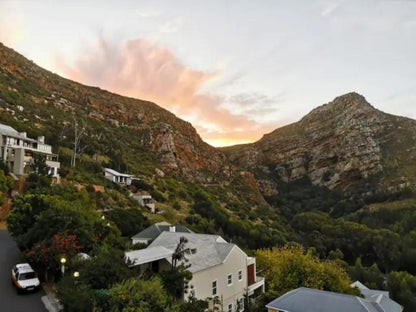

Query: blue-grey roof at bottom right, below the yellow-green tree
[[266, 286, 403, 312]]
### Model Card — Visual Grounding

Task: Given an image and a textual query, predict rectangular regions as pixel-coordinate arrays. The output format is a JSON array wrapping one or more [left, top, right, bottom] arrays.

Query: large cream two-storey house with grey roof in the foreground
[[125, 231, 264, 312]]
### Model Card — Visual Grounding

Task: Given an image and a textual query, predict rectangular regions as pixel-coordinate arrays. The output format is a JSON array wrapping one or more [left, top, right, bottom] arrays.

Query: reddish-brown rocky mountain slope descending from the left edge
[[0, 43, 225, 181]]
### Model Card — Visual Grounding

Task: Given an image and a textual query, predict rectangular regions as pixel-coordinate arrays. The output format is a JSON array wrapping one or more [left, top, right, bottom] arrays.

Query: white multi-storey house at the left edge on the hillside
[[0, 124, 60, 182]]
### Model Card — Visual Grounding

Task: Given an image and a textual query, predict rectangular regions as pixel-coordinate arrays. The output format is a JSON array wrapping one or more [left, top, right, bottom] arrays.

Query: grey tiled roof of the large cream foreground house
[[148, 232, 239, 273]]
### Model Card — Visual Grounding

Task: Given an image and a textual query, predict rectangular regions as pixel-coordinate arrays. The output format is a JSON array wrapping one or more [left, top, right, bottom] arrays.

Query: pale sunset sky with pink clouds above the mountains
[[0, 0, 416, 146]]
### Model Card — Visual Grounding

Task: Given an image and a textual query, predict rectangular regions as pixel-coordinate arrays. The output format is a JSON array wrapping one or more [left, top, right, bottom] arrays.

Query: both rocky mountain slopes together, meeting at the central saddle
[[0, 40, 416, 204]]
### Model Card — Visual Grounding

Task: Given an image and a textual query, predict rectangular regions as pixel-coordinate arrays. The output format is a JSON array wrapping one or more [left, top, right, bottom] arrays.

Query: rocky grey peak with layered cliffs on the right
[[224, 93, 416, 195]]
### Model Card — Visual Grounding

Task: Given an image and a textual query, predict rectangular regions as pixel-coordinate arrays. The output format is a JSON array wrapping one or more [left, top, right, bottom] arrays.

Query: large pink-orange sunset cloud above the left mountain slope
[[56, 38, 271, 145]]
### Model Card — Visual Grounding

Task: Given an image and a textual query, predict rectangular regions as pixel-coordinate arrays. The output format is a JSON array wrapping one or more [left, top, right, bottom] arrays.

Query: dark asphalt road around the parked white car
[[0, 230, 46, 312]]
